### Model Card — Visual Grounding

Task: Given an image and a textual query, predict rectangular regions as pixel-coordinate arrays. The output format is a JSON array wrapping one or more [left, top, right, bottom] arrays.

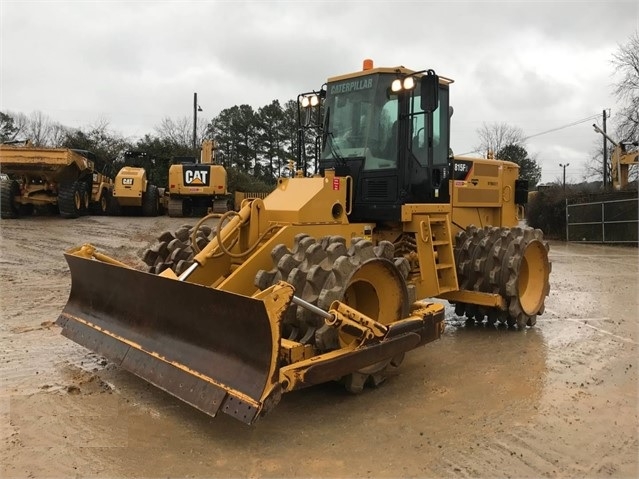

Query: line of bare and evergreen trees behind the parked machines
[[0, 100, 313, 194]]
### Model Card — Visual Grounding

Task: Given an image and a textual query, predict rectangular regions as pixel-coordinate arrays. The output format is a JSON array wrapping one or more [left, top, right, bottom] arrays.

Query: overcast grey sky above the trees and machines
[[0, 0, 639, 182]]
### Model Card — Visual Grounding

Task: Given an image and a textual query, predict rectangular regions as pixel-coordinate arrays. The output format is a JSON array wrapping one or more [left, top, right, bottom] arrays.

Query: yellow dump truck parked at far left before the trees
[[0, 141, 113, 219]]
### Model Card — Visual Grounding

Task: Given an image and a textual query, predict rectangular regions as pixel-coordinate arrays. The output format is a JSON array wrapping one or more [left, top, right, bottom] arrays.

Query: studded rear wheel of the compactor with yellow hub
[[455, 226, 551, 329]]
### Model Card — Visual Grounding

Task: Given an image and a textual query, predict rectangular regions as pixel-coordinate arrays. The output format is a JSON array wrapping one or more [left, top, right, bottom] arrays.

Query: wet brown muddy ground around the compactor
[[0, 217, 639, 478]]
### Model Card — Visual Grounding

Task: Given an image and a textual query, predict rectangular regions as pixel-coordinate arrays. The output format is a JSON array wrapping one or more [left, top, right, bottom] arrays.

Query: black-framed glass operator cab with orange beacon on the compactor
[[312, 62, 452, 221]]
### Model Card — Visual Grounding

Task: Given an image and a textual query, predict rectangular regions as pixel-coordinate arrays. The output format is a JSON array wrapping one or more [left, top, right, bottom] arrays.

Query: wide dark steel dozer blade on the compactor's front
[[57, 253, 293, 424]]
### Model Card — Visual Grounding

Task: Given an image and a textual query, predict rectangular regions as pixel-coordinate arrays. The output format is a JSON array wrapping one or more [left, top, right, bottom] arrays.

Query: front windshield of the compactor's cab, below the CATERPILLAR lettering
[[321, 75, 398, 170]]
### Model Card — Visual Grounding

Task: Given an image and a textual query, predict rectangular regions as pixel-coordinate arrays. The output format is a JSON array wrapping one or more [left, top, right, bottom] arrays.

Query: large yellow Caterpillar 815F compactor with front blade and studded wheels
[[58, 61, 550, 423]]
